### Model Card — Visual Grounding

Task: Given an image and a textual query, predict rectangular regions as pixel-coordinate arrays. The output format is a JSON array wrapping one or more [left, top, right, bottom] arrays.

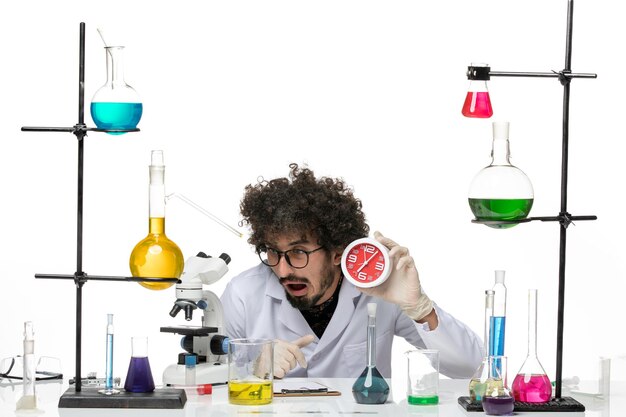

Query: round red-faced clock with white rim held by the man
[[341, 237, 391, 288]]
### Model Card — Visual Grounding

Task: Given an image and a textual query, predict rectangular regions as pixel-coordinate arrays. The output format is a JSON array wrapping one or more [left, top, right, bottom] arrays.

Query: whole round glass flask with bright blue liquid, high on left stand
[[91, 46, 143, 135]]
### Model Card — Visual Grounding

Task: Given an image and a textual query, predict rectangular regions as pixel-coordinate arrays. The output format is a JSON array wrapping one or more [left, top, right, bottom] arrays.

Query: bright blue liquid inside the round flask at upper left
[[91, 102, 143, 135]]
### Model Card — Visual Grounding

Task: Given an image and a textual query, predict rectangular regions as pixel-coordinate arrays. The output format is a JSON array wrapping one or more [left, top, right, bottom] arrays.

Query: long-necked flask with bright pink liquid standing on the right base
[[511, 290, 552, 403]]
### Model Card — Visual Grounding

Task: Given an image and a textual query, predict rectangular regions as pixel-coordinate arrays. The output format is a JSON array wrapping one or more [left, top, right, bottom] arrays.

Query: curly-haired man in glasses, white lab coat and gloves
[[221, 164, 483, 378]]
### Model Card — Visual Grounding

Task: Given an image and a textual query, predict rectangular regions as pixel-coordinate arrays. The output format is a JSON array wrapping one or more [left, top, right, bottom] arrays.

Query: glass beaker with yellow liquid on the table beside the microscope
[[228, 339, 274, 405]]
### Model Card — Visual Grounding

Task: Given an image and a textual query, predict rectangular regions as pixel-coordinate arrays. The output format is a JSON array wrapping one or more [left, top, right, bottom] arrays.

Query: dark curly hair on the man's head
[[240, 163, 369, 250]]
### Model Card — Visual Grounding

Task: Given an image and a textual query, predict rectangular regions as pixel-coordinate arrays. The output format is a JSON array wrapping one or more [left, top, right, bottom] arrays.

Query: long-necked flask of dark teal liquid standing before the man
[[352, 303, 389, 404]]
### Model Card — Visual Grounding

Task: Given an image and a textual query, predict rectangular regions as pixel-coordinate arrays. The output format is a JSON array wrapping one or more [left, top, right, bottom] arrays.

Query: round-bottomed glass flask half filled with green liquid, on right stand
[[468, 122, 534, 229]]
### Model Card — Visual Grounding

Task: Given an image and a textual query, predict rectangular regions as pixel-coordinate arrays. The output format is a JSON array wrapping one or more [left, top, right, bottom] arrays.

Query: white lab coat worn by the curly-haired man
[[221, 264, 483, 378]]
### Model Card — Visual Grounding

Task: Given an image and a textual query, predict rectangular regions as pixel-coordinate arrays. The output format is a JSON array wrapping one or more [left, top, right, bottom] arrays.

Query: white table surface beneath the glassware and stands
[[0, 378, 626, 417]]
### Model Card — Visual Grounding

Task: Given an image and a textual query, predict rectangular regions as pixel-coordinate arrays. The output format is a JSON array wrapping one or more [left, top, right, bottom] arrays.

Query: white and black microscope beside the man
[[161, 252, 230, 386]]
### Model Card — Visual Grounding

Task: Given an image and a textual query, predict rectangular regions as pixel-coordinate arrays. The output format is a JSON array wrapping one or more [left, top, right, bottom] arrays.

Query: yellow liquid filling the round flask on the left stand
[[129, 217, 185, 290]]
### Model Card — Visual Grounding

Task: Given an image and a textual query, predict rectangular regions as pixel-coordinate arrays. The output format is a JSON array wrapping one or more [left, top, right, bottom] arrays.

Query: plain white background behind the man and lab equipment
[[0, 0, 626, 386]]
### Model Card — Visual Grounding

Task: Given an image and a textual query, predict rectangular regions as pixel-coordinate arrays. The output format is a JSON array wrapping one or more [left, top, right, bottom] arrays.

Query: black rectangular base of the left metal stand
[[59, 387, 187, 408]]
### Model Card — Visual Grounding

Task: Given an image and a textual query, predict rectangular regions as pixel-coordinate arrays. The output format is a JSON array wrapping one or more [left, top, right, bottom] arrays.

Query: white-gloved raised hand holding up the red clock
[[359, 232, 433, 320]]
